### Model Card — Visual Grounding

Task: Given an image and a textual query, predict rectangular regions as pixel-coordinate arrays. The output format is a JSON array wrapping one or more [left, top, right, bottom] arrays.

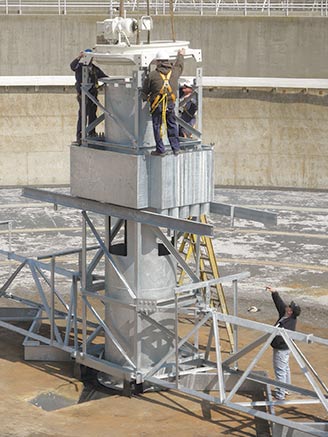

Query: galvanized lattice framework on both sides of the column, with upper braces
[[0, 189, 328, 436]]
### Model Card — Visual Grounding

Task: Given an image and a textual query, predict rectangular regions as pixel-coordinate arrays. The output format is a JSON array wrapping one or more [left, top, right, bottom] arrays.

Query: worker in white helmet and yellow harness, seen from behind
[[141, 49, 185, 156]]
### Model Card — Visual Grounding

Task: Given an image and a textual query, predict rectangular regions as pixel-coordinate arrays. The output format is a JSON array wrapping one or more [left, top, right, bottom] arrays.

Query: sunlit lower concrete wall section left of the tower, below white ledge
[[0, 90, 73, 186]]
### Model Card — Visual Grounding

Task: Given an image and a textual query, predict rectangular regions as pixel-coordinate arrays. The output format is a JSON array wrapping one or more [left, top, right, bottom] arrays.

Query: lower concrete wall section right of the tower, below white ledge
[[203, 90, 328, 189]]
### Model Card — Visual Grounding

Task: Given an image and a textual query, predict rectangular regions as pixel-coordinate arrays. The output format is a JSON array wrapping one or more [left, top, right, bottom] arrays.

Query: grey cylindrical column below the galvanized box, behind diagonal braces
[[105, 222, 176, 372]]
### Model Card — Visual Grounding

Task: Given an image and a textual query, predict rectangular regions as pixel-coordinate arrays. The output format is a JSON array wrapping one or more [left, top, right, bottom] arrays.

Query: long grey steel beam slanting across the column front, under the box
[[22, 187, 213, 237]]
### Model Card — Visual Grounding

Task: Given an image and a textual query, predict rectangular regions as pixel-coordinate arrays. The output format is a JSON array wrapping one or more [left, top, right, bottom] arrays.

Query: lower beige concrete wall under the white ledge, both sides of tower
[[0, 87, 328, 189]]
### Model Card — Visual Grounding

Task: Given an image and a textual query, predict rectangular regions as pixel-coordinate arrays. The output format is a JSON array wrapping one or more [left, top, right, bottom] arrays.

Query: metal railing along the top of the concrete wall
[[0, 0, 328, 17]]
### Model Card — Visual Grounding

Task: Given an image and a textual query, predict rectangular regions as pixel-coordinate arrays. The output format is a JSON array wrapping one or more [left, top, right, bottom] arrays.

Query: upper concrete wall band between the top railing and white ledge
[[0, 15, 328, 78]]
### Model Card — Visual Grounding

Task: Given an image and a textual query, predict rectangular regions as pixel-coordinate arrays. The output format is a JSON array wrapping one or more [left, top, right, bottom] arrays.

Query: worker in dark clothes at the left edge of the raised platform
[[70, 49, 108, 145]]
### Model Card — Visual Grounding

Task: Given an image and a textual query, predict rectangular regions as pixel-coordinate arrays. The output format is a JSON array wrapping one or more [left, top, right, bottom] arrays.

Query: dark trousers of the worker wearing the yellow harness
[[152, 103, 180, 153]]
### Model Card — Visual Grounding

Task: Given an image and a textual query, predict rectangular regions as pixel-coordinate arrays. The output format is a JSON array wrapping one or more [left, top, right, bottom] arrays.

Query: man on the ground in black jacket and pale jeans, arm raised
[[266, 287, 301, 400]]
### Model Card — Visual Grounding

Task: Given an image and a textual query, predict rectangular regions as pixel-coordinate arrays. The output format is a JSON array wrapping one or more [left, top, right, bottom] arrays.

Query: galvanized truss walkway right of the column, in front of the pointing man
[[145, 282, 328, 436]]
